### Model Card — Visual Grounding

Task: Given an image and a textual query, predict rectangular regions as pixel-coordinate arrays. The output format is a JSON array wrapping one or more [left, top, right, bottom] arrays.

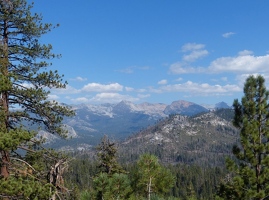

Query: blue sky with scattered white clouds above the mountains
[[33, 0, 269, 105]]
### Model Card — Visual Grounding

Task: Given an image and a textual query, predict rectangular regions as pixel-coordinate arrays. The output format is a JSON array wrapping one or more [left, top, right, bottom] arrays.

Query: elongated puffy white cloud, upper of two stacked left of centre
[[81, 83, 123, 92]]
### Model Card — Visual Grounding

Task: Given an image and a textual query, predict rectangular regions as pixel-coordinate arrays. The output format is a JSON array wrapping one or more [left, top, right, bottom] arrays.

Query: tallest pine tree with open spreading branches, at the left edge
[[0, 0, 73, 199]]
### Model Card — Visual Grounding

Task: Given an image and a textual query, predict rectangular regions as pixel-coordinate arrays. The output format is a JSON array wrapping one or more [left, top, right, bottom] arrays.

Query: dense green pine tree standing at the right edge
[[219, 76, 269, 200]]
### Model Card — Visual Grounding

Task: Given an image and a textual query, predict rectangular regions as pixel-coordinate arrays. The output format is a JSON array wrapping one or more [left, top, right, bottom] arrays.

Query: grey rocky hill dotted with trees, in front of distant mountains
[[119, 109, 239, 166]]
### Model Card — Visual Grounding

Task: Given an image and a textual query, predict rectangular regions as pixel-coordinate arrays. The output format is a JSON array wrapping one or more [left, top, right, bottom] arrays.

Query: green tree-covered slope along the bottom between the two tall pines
[[65, 142, 226, 200]]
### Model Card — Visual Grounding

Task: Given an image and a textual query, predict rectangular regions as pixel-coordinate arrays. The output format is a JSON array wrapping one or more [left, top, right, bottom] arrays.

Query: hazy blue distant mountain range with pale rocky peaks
[[39, 100, 230, 148]]
